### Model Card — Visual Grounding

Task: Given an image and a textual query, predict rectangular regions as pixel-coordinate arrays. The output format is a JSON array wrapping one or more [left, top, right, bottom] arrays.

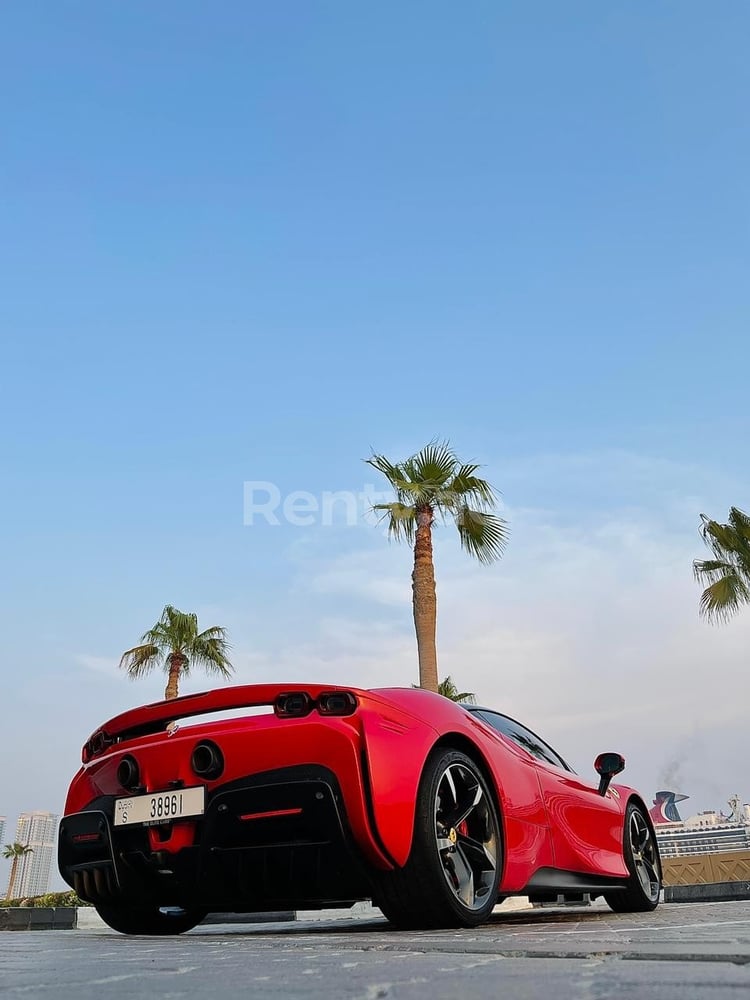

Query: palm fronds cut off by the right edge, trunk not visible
[[693, 507, 750, 622]]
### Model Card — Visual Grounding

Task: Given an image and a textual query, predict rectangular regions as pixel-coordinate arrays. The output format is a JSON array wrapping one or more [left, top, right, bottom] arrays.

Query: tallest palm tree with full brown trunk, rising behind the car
[[367, 441, 507, 691]]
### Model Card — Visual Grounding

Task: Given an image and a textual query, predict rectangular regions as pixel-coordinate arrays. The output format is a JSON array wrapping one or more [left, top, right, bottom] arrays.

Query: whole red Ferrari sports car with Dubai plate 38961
[[59, 684, 661, 934]]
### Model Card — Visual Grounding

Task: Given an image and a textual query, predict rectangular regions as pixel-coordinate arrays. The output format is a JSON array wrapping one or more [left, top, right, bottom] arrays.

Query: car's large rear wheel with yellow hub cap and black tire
[[375, 748, 502, 928]]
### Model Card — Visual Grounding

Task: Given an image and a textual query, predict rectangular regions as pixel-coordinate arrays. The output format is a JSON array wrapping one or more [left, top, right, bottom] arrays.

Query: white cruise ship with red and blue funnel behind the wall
[[649, 791, 750, 858]]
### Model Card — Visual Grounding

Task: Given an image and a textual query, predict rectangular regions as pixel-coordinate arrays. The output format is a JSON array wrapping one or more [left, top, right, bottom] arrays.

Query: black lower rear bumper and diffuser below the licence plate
[[58, 766, 371, 911]]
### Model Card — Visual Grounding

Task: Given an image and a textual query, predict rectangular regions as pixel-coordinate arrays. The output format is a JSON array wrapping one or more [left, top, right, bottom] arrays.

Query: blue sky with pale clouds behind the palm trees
[[0, 0, 750, 888]]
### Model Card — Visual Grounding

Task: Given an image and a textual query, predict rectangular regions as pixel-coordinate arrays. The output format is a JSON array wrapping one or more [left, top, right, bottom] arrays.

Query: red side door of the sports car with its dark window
[[480, 710, 623, 875]]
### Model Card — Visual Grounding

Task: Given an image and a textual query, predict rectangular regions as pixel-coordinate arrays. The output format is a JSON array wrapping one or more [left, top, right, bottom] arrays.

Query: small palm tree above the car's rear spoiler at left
[[120, 604, 234, 701]]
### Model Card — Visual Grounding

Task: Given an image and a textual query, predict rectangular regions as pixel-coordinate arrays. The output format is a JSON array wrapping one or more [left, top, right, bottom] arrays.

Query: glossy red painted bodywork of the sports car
[[61, 684, 648, 912]]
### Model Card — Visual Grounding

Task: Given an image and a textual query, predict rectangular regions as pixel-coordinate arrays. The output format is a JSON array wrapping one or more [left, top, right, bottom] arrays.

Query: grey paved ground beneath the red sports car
[[0, 901, 750, 1000]]
